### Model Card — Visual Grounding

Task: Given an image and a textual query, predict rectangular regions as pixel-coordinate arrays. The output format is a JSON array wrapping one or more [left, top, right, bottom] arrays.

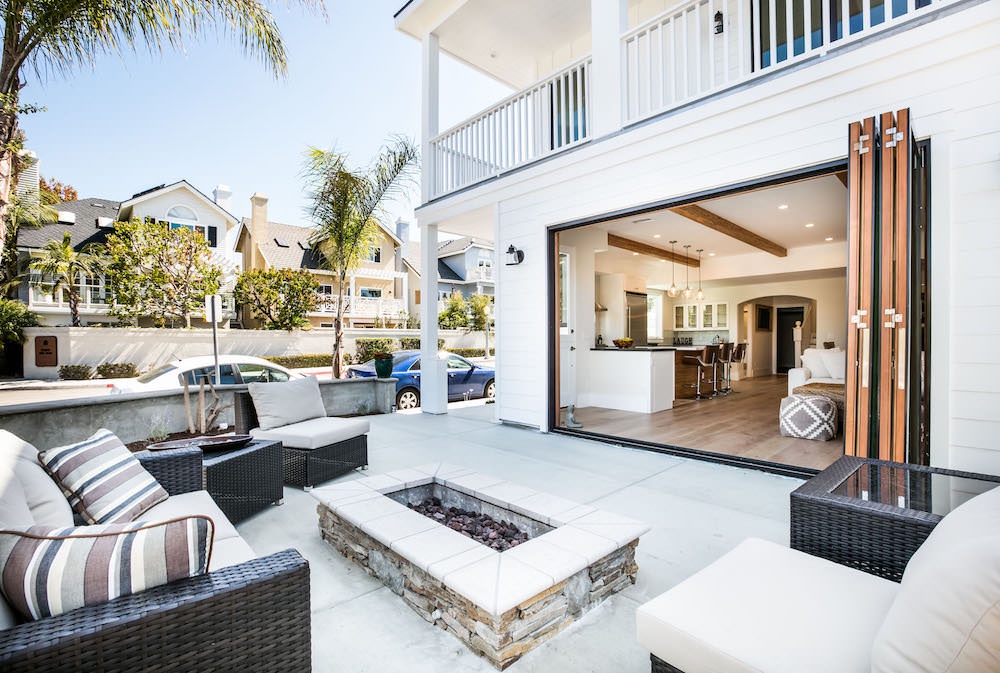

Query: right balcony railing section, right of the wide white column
[[622, 0, 954, 123]]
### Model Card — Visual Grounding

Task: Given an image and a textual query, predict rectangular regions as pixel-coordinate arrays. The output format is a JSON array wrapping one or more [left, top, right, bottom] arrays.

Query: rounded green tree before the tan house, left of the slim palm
[[233, 269, 320, 330]]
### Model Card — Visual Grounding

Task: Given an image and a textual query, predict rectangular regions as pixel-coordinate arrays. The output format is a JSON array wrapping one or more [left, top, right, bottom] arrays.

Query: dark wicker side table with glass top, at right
[[790, 456, 1000, 582]]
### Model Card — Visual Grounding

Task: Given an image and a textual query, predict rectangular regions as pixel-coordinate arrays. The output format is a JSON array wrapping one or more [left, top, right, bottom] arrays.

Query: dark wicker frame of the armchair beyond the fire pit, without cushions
[[233, 392, 368, 490]]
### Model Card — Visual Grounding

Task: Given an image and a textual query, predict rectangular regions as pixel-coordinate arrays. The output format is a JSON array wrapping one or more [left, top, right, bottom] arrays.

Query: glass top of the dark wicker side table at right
[[830, 463, 1000, 516]]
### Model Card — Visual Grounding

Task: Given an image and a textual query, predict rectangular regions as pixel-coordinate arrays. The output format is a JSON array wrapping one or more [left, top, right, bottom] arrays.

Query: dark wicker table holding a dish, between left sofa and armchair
[[202, 440, 284, 523]]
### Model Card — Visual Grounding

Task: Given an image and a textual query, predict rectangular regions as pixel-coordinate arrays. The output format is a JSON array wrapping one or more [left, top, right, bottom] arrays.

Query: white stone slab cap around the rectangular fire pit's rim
[[310, 463, 650, 615]]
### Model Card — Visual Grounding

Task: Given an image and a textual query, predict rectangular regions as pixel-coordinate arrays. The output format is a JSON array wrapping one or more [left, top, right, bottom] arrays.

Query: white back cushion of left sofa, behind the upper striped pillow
[[0, 430, 73, 527]]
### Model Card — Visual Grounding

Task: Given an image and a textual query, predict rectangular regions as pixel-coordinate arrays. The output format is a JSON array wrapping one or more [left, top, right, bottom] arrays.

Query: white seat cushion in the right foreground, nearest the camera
[[636, 538, 898, 673]]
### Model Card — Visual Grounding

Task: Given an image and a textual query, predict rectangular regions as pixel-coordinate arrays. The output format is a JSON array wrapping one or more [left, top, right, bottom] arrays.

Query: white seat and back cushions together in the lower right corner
[[636, 488, 1000, 673]]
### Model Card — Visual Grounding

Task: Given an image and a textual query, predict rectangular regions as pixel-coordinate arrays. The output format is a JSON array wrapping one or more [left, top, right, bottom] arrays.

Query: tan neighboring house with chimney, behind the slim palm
[[236, 194, 419, 327]]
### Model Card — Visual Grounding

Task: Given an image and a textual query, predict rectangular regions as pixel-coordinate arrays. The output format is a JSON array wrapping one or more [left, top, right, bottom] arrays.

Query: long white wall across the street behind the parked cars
[[24, 327, 493, 379]]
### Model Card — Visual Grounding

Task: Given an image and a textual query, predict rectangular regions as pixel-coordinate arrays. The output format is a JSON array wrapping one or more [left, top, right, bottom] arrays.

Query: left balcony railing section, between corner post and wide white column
[[424, 56, 591, 198]]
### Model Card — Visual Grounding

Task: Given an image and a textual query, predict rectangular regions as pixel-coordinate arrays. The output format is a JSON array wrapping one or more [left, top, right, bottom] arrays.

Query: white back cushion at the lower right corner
[[872, 488, 1000, 673]]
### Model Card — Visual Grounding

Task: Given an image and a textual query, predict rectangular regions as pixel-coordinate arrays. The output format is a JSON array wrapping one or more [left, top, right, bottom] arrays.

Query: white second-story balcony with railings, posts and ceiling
[[396, 0, 958, 202]]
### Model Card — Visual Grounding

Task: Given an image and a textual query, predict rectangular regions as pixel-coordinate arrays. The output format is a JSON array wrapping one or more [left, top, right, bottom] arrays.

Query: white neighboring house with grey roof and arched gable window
[[18, 180, 239, 325]]
